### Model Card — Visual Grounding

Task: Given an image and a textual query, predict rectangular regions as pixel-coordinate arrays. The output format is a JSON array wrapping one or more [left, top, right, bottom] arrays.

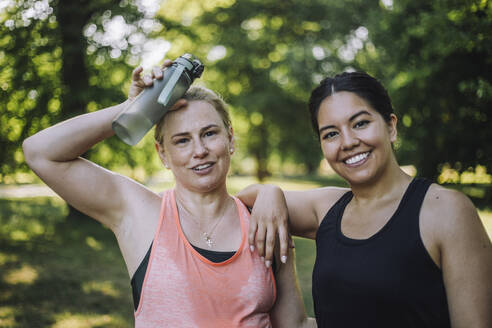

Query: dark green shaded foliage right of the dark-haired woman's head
[[356, 1, 492, 177]]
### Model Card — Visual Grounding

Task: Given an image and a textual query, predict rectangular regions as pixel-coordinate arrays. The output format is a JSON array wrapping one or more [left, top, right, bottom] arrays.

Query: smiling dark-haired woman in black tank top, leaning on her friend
[[239, 73, 492, 328]]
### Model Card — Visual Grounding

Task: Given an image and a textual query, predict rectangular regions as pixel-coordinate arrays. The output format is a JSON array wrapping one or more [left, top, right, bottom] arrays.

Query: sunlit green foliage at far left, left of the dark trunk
[[0, 2, 60, 178]]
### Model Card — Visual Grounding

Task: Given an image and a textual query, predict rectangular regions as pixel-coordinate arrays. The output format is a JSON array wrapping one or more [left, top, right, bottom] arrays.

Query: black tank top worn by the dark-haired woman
[[312, 179, 450, 328]]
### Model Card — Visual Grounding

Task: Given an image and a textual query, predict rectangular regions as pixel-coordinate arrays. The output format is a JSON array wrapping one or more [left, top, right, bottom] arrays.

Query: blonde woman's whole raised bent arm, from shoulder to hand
[[22, 61, 171, 231]]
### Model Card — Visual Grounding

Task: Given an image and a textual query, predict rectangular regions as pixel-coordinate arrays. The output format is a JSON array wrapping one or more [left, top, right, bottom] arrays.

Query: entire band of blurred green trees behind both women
[[0, 0, 492, 181]]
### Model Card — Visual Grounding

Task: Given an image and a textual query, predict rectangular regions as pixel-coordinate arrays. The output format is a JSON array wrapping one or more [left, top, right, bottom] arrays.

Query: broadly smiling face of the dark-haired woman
[[317, 91, 397, 185]]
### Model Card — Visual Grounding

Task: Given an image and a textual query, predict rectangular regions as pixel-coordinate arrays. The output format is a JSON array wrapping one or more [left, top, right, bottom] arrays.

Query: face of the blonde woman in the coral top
[[158, 101, 233, 192]]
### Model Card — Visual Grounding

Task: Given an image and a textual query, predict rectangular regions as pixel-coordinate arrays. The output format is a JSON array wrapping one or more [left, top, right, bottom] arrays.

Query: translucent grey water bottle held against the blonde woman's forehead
[[112, 54, 204, 146]]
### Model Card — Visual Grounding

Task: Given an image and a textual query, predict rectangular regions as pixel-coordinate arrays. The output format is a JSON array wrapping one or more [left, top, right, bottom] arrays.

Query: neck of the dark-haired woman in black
[[350, 159, 412, 202]]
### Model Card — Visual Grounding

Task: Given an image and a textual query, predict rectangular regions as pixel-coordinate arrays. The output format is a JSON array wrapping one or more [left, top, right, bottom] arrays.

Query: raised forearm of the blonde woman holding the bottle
[[23, 101, 128, 165]]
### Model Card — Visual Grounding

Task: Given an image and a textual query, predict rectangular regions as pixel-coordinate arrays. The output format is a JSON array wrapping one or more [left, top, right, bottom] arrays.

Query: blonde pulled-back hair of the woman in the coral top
[[154, 86, 231, 146]]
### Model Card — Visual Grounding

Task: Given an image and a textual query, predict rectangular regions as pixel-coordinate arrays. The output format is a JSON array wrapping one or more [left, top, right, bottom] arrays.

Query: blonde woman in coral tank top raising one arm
[[23, 61, 313, 327]]
